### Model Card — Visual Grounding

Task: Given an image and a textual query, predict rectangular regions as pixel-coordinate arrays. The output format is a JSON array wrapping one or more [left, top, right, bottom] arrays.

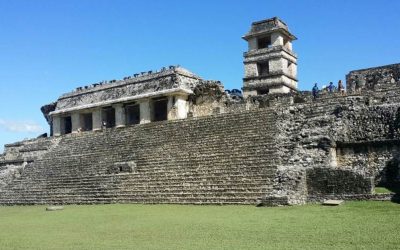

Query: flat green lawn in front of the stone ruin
[[0, 202, 400, 249]]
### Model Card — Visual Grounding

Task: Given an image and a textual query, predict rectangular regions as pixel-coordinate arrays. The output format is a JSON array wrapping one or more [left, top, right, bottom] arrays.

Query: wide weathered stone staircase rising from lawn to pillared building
[[0, 109, 279, 205]]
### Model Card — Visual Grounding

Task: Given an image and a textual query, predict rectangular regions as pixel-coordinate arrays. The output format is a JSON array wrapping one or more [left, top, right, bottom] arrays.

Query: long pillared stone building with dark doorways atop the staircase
[[42, 66, 211, 136]]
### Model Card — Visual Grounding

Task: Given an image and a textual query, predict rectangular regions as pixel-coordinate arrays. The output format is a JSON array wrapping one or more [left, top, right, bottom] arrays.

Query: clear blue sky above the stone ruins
[[0, 0, 400, 152]]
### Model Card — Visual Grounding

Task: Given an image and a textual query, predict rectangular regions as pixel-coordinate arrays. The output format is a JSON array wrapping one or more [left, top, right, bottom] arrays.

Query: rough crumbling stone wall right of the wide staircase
[[260, 90, 400, 205]]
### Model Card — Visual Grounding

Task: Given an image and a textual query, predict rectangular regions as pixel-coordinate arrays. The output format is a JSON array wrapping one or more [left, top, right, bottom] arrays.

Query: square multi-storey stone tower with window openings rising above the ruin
[[243, 17, 297, 97]]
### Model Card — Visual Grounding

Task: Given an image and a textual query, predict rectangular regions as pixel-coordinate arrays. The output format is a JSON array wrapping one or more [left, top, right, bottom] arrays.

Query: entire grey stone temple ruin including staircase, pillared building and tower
[[0, 18, 400, 205]]
